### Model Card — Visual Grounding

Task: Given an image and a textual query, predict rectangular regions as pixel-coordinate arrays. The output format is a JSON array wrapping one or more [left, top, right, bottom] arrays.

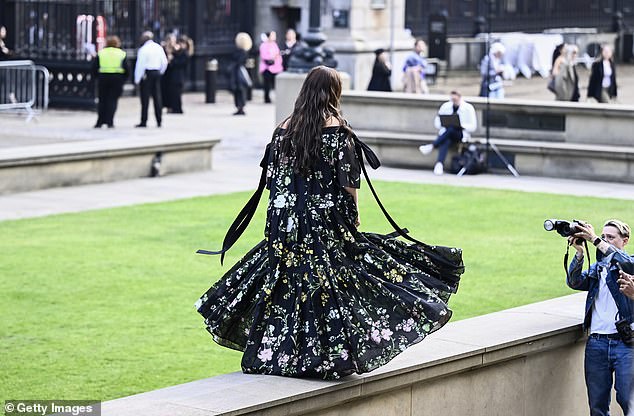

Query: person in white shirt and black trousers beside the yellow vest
[[134, 31, 167, 127]]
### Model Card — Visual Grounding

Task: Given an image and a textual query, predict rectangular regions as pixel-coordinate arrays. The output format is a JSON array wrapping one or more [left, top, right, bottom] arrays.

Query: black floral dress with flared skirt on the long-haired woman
[[195, 127, 464, 379]]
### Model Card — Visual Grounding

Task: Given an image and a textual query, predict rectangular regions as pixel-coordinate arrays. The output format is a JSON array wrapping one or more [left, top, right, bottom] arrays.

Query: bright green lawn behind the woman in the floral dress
[[0, 182, 634, 400]]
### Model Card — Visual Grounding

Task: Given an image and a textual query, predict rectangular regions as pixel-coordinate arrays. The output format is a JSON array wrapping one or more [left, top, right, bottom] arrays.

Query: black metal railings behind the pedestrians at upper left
[[0, 0, 255, 107]]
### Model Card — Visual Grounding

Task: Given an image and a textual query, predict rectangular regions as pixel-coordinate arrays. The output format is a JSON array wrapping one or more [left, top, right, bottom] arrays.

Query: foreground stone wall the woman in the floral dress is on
[[102, 294, 620, 416]]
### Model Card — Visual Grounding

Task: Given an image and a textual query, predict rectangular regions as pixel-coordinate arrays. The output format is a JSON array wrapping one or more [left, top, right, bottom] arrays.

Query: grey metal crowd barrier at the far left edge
[[0, 60, 49, 121]]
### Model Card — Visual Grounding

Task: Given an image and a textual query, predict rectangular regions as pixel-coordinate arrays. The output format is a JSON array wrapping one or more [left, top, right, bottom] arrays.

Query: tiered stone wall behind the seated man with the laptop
[[342, 91, 634, 183]]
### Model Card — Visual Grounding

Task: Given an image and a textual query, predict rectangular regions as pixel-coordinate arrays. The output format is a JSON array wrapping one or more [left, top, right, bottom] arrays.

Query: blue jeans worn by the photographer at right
[[585, 336, 634, 416]]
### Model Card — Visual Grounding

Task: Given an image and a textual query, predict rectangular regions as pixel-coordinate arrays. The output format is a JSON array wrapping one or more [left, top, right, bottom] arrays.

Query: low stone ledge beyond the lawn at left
[[0, 137, 220, 195]]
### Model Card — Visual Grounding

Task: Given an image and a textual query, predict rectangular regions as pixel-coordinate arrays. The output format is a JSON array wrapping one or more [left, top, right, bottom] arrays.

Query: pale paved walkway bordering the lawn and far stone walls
[[0, 71, 634, 220]]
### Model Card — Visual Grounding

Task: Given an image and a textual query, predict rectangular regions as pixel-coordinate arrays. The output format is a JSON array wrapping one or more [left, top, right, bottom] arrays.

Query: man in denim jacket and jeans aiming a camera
[[566, 220, 634, 416]]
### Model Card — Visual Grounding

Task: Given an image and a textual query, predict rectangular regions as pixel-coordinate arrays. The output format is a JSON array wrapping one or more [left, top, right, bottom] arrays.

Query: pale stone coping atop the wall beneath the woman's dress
[[102, 293, 585, 416]]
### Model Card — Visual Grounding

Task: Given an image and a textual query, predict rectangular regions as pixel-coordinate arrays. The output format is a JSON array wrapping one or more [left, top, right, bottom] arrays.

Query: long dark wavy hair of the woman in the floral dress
[[280, 66, 350, 177]]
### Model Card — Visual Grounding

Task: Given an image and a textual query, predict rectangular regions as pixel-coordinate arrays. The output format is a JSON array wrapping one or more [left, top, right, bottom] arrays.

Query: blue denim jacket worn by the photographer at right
[[566, 246, 634, 330]]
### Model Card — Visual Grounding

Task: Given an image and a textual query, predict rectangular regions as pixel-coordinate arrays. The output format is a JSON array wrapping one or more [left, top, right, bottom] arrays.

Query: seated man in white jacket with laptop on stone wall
[[419, 91, 478, 175]]
